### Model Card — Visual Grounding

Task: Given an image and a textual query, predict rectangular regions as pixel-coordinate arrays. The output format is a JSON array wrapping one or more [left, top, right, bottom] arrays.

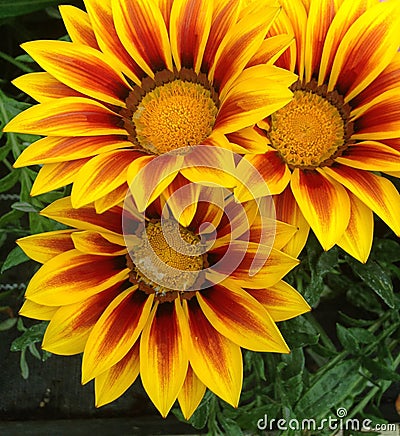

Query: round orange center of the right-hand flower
[[268, 89, 346, 168]]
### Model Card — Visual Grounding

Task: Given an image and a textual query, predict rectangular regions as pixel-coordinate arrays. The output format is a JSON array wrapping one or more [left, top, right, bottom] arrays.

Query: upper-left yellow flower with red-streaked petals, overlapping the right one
[[5, 0, 296, 212]]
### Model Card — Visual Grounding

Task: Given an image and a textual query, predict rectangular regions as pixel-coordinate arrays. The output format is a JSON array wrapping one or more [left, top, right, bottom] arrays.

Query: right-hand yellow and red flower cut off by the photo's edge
[[238, 0, 400, 262]]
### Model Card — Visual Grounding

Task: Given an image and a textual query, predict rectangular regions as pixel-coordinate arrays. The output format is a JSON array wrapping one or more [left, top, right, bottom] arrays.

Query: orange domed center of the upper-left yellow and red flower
[[132, 79, 218, 154]]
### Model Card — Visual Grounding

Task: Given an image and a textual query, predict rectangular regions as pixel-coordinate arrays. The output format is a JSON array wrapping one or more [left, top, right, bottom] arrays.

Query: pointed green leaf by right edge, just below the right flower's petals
[[348, 258, 395, 309]]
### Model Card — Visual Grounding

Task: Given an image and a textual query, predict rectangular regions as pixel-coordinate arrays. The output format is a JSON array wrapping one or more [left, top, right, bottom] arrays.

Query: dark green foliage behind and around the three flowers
[[0, 0, 400, 435]]
